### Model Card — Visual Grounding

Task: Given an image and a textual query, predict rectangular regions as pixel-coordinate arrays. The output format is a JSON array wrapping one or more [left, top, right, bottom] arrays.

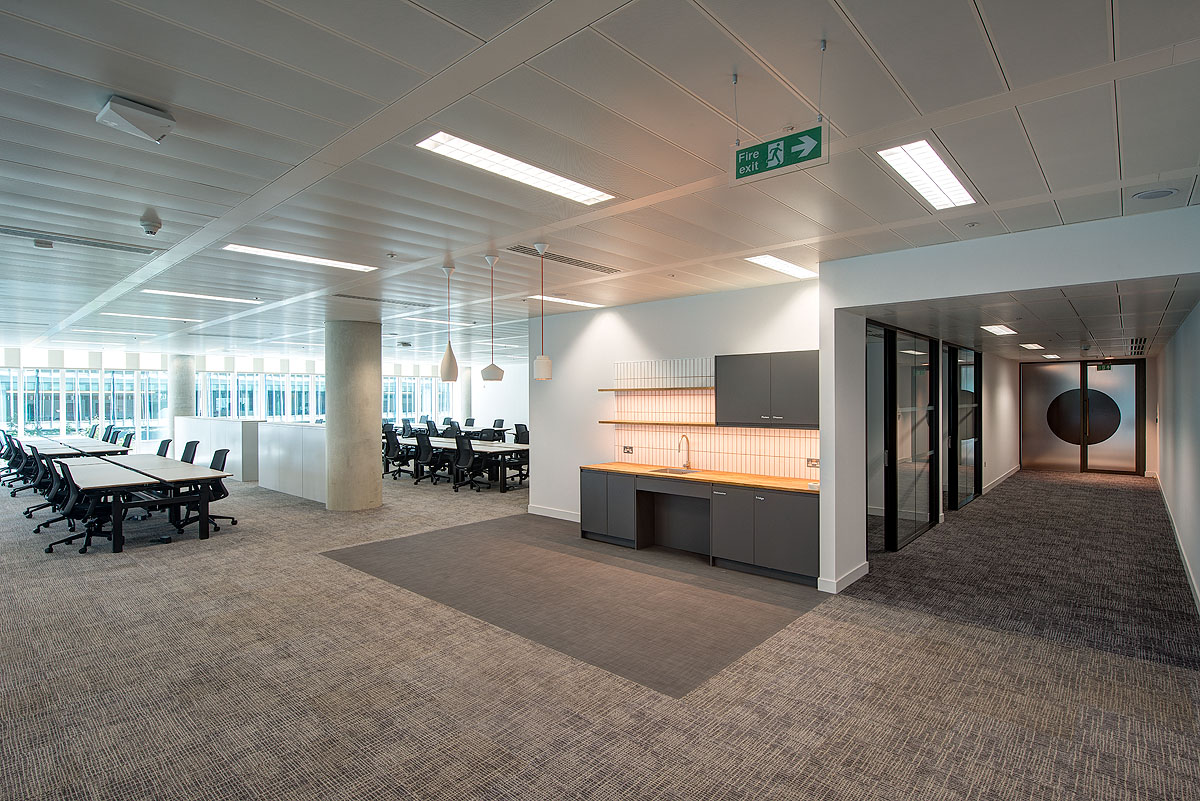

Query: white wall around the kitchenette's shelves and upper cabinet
[[530, 281, 817, 520]]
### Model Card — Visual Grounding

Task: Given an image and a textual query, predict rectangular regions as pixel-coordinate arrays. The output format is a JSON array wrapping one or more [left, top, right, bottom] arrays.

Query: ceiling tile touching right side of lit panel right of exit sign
[[935, 109, 1046, 203]]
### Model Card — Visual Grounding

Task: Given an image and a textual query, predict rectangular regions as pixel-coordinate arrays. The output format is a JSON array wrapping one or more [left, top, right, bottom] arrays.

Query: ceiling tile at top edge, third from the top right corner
[[840, 0, 1007, 114]]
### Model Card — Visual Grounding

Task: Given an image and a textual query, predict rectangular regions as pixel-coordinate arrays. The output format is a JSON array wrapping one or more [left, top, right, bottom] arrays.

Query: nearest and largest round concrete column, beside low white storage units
[[325, 320, 383, 512]]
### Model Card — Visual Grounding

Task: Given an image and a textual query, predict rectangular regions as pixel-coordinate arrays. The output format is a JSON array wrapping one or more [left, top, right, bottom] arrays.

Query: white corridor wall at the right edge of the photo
[[1157, 308, 1200, 608]]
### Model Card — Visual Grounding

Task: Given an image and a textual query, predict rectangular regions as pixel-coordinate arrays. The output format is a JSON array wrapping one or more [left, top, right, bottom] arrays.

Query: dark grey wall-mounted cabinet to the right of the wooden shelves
[[714, 350, 820, 428]]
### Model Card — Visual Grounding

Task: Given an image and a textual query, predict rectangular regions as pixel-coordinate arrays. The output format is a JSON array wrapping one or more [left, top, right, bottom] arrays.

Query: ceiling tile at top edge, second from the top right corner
[[978, 0, 1112, 89]]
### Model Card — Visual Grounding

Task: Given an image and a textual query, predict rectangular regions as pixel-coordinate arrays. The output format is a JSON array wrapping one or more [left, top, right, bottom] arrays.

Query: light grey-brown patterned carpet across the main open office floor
[[0, 465, 1200, 801]]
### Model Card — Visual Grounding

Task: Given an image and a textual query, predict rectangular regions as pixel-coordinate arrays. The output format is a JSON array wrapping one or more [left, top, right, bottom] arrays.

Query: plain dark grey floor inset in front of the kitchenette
[[325, 514, 822, 698]]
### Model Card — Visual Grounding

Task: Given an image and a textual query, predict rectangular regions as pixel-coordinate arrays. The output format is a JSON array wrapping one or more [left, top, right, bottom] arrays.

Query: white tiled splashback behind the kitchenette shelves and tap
[[612, 359, 821, 481]]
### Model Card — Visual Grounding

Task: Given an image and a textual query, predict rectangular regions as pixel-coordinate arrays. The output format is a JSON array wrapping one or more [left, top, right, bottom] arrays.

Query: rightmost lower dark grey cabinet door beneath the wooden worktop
[[752, 489, 821, 576]]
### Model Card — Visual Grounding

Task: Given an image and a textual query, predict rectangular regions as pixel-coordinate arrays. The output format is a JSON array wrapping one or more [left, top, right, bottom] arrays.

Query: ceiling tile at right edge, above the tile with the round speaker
[[1117, 58, 1200, 177]]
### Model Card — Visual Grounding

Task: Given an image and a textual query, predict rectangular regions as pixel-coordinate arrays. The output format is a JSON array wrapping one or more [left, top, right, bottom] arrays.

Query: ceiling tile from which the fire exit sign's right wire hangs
[[703, 0, 916, 135]]
